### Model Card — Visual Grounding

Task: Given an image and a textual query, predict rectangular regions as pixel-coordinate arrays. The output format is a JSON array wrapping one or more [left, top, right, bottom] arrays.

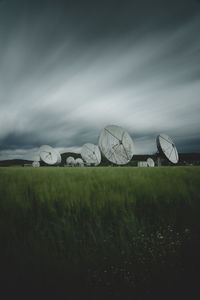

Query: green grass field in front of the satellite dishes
[[0, 167, 200, 299]]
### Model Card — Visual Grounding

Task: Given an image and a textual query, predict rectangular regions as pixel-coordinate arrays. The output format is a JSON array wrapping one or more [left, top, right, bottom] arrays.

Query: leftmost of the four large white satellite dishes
[[40, 145, 61, 165]]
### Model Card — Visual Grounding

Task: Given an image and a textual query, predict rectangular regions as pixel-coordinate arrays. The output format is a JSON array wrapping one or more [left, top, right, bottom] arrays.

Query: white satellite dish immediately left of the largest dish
[[81, 143, 101, 166]]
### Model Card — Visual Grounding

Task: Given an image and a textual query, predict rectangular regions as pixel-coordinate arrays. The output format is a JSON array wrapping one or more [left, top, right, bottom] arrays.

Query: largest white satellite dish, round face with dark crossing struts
[[99, 125, 134, 165]]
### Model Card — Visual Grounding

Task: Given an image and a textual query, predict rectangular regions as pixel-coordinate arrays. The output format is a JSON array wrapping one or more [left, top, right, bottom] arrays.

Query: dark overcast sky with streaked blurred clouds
[[0, 0, 200, 160]]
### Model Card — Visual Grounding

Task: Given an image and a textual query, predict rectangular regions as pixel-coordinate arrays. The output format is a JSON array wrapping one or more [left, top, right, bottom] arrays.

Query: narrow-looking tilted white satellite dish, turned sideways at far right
[[156, 133, 178, 164]]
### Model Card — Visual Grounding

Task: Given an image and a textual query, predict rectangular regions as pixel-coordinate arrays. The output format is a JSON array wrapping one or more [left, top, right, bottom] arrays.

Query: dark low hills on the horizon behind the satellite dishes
[[0, 152, 200, 167]]
